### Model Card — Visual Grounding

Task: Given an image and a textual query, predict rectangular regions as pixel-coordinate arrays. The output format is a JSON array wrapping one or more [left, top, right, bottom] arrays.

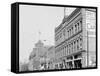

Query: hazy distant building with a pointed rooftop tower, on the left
[[29, 40, 50, 71]]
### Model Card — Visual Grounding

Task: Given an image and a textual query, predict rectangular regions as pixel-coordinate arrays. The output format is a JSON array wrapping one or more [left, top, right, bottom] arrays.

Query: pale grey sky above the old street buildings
[[19, 5, 76, 62]]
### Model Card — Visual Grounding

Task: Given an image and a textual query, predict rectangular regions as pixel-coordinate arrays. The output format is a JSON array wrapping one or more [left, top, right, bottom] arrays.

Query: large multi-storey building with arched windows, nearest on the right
[[55, 8, 96, 69]]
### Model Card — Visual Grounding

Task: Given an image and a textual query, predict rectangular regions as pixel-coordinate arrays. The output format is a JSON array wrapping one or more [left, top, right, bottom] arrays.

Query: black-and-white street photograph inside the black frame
[[19, 5, 97, 72]]
